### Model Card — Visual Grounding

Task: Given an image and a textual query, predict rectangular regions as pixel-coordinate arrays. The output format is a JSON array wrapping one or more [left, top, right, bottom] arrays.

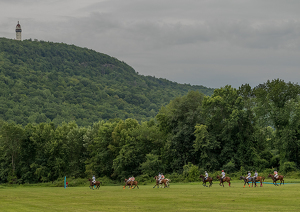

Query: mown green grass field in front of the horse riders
[[0, 181, 300, 212]]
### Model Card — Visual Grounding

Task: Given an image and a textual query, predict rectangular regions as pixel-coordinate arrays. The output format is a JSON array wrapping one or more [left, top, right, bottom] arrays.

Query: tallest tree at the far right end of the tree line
[[253, 79, 300, 165]]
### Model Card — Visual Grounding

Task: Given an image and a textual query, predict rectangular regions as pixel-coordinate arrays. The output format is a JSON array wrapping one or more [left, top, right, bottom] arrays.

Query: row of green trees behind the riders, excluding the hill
[[0, 79, 300, 183]]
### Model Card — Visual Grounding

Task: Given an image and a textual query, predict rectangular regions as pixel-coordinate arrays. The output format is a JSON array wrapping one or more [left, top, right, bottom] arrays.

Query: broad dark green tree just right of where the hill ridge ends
[[194, 85, 257, 170]]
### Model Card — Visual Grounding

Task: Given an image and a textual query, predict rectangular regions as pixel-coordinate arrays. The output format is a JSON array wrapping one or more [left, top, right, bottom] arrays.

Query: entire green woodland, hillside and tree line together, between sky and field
[[0, 38, 300, 183]]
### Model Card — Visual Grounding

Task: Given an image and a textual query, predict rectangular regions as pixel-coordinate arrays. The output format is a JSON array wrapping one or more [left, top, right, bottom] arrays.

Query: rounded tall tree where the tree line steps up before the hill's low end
[[156, 91, 204, 171]]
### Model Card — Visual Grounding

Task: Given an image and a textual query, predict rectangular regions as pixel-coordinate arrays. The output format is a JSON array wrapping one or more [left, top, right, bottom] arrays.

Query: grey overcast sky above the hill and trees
[[0, 0, 300, 88]]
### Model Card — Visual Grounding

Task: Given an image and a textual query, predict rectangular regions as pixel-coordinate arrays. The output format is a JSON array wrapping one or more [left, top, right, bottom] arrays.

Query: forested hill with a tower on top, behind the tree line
[[0, 38, 213, 126]]
